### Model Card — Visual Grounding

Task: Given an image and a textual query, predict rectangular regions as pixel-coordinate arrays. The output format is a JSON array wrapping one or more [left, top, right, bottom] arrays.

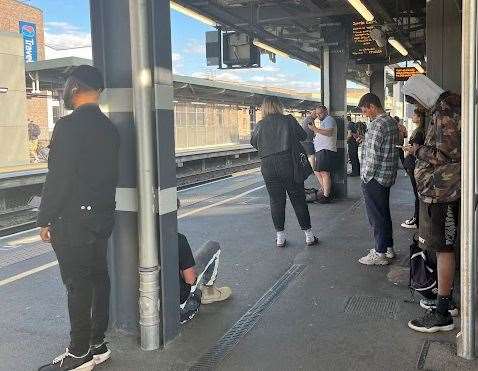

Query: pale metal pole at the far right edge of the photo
[[457, 0, 478, 359]]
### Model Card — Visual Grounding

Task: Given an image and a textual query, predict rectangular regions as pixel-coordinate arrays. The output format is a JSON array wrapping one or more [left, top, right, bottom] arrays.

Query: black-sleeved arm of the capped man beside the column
[[37, 121, 78, 227]]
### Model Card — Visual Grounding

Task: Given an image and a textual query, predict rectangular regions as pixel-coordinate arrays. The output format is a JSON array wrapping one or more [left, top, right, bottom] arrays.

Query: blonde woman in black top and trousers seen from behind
[[251, 97, 318, 247]]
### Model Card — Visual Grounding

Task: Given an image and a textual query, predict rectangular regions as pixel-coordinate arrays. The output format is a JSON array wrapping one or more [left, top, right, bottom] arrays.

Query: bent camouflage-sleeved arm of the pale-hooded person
[[415, 116, 461, 166]]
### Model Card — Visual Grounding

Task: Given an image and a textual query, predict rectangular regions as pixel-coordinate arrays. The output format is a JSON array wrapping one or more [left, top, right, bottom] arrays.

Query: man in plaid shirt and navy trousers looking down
[[359, 93, 399, 265]]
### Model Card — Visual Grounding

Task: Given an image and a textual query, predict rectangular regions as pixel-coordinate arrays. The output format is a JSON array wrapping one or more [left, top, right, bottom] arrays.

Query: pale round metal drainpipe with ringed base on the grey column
[[129, 0, 160, 350]]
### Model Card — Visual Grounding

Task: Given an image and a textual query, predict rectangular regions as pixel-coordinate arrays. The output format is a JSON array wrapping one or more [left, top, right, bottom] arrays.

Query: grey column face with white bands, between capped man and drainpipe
[[90, 0, 138, 334]]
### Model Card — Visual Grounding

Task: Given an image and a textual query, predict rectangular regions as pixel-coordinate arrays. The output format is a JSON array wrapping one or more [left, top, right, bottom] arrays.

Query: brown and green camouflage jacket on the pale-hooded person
[[415, 95, 461, 203]]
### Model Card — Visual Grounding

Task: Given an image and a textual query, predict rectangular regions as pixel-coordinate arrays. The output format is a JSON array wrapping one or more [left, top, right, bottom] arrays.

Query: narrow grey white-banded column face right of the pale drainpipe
[[151, 0, 179, 344]]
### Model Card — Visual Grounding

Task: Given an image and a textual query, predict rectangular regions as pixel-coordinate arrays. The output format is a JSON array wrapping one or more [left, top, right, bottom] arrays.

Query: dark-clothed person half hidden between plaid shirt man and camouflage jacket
[[401, 109, 425, 229]]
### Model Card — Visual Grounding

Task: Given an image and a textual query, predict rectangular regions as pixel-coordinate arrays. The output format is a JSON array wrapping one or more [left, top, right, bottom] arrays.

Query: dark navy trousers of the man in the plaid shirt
[[362, 179, 393, 253]]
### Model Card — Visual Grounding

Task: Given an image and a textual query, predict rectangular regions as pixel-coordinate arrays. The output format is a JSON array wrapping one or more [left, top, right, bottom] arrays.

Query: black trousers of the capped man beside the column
[[52, 235, 110, 355]]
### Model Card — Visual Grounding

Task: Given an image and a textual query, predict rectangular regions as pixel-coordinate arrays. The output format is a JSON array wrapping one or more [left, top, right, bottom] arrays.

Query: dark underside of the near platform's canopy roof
[[174, 0, 426, 84]]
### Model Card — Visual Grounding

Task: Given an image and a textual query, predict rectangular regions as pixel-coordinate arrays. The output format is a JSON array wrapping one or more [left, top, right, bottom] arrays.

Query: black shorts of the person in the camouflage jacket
[[418, 201, 460, 252]]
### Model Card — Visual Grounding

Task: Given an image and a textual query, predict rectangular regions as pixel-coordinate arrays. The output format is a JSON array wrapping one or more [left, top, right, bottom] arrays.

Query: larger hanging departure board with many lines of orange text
[[350, 21, 387, 64]]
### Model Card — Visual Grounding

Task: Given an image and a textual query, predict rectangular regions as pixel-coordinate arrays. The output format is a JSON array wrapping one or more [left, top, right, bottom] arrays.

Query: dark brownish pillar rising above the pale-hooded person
[[426, 0, 462, 94]]
